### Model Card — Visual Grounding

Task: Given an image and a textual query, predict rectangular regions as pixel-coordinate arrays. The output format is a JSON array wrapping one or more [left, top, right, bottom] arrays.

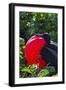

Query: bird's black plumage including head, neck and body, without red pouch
[[37, 33, 58, 73]]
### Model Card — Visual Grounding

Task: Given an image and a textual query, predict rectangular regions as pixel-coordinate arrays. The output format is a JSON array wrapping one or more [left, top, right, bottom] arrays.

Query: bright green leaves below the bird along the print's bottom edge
[[20, 64, 56, 78]]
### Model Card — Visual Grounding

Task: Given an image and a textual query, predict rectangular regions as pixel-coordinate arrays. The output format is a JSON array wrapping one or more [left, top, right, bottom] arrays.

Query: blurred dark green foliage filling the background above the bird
[[19, 12, 58, 42]]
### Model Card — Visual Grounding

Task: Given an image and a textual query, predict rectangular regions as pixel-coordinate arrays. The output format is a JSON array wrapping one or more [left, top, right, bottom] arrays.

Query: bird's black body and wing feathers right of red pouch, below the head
[[41, 44, 58, 73]]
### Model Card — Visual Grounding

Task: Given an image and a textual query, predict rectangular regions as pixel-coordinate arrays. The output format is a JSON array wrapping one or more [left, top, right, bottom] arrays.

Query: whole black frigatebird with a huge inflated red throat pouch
[[25, 33, 58, 72]]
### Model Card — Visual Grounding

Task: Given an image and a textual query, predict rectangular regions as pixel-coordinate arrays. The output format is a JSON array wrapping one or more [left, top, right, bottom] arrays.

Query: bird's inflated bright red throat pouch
[[25, 35, 46, 68]]
